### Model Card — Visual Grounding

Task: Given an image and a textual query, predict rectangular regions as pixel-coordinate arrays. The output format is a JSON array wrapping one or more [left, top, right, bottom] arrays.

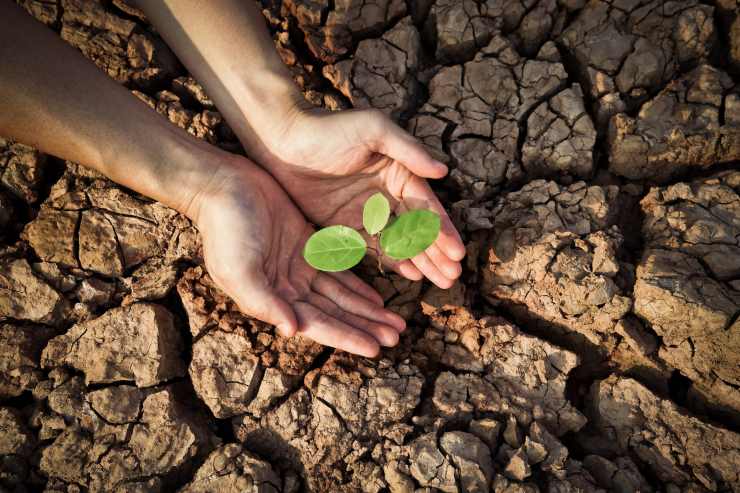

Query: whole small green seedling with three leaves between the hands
[[303, 193, 440, 272]]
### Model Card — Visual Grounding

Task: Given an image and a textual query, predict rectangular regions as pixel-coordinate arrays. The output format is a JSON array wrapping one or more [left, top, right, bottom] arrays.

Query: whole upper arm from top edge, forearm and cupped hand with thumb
[[133, 0, 465, 288]]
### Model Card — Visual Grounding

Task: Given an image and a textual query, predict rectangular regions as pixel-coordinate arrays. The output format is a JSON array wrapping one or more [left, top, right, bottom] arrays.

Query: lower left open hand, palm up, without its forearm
[[188, 155, 405, 357]]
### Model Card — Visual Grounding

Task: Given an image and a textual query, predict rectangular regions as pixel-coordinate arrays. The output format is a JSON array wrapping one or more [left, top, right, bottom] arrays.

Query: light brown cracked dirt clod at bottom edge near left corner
[[40, 386, 216, 491]]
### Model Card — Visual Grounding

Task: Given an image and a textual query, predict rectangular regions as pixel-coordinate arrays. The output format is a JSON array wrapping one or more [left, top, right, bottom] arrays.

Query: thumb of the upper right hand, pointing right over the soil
[[372, 113, 447, 179]]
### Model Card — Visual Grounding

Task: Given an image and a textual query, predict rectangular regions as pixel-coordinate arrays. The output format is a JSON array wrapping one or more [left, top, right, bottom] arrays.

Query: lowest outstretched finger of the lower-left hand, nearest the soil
[[294, 301, 380, 358]]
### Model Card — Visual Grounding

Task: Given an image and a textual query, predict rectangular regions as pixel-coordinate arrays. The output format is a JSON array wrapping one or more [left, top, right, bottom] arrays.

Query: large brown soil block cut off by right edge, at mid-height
[[634, 171, 740, 418]]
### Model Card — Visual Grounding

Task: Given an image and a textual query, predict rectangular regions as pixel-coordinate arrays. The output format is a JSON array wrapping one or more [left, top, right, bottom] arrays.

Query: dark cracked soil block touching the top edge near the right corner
[[559, 0, 717, 123]]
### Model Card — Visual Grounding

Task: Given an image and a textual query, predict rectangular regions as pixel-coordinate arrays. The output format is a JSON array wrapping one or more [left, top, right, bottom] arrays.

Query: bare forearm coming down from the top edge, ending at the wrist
[[135, 0, 307, 164]]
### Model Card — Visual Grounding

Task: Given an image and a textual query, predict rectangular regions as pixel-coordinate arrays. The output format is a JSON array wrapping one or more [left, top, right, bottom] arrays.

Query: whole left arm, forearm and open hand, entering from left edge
[[0, 2, 405, 356]]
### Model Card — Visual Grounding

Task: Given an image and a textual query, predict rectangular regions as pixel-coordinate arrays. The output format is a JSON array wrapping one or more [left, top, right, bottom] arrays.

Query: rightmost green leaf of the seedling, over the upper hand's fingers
[[380, 209, 440, 260]]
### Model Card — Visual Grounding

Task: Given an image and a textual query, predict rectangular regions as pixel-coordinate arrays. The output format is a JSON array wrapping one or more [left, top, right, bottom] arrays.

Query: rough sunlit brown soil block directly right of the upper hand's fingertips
[[483, 180, 632, 351]]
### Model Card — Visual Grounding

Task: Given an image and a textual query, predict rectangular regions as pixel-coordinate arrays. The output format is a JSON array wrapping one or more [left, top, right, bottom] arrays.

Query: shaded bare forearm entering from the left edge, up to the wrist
[[0, 2, 220, 217]]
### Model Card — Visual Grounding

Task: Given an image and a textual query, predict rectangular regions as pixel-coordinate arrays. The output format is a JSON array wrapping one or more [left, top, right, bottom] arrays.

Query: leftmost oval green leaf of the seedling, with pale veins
[[303, 226, 367, 272]]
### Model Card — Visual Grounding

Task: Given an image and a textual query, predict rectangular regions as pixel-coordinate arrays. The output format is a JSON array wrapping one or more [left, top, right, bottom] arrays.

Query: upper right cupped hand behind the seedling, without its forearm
[[250, 109, 465, 288]]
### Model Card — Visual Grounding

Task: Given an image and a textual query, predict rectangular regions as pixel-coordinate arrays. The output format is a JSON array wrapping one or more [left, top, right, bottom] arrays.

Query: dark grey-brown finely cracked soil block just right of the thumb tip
[[409, 34, 596, 198]]
